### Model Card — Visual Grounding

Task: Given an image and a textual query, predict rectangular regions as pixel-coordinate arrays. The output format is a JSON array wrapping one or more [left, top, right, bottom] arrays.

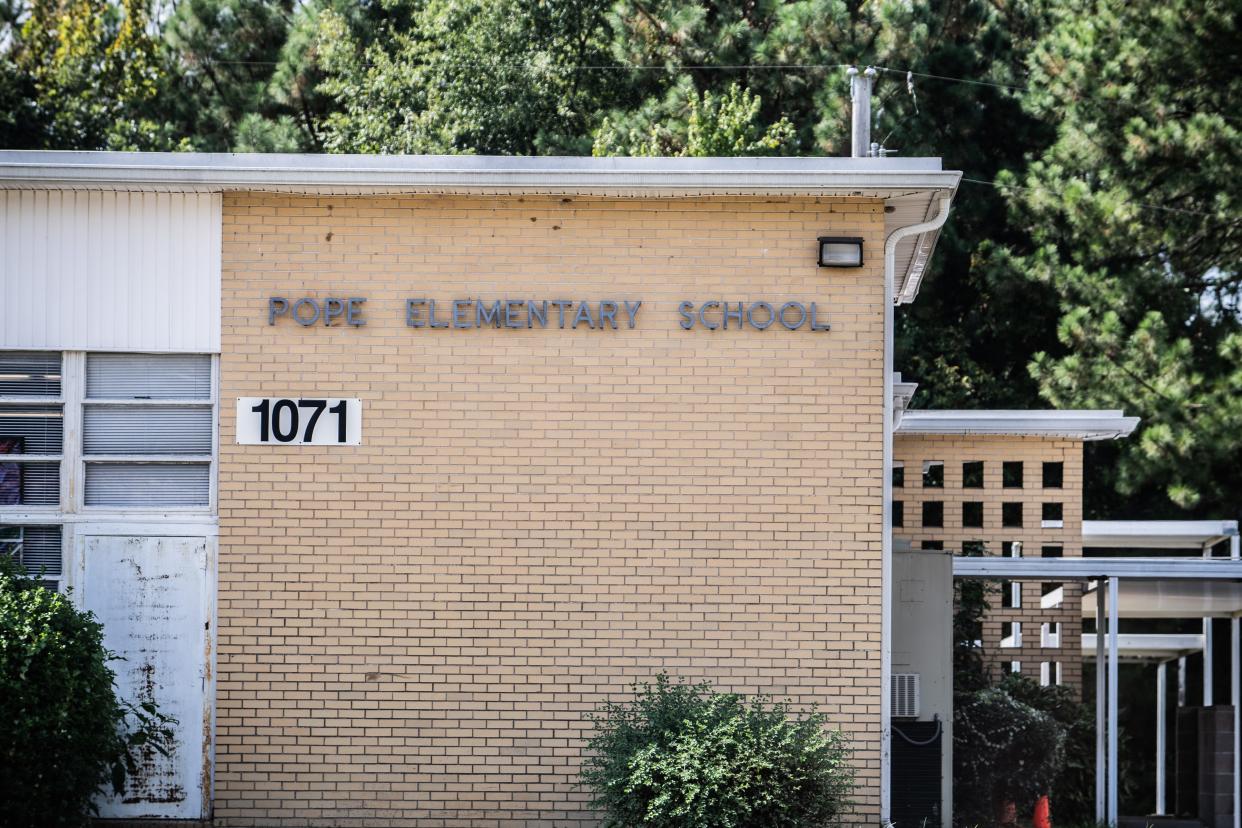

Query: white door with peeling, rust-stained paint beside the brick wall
[[77, 528, 211, 819]]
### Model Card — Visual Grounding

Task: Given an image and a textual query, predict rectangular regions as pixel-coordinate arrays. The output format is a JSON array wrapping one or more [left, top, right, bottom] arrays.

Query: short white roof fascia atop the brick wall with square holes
[[897, 410, 1139, 441]]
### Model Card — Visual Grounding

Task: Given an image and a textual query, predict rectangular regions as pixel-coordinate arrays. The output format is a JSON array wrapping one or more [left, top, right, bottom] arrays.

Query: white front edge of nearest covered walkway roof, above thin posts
[[953, 556, 1242, 581]]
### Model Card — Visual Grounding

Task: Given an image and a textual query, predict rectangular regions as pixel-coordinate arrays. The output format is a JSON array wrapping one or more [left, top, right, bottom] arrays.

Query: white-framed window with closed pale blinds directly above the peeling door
[[82, 354, 215, 509]]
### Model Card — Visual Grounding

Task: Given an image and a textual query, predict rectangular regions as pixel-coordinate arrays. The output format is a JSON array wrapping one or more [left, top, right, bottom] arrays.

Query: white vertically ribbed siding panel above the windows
[[0, 190, 220, 353]]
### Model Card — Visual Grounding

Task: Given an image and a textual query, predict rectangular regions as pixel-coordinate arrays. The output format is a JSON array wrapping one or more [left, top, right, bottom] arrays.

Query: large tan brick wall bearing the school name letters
[[215, 195, 883, 826]]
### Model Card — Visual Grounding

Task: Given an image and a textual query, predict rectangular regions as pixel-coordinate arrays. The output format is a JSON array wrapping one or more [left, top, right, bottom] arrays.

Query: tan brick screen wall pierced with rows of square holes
[[893, 433, 1083, 693]]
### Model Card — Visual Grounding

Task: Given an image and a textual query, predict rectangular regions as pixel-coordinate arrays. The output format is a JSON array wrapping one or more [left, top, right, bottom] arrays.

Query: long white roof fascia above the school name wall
[[0, 150, 961, 197]]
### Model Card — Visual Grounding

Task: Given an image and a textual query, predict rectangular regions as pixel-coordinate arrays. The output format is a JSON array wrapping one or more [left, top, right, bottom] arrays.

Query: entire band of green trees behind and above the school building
[[0, 0, 1242, 516]]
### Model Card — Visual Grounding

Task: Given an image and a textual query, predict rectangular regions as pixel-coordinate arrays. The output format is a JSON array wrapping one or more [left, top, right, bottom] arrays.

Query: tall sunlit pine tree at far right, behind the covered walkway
[[1000, 0, 1242, 515]]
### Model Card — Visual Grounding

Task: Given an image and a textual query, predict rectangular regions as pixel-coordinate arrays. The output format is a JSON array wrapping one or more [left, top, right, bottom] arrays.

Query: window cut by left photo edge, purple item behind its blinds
[[0, 351, 65, 511]]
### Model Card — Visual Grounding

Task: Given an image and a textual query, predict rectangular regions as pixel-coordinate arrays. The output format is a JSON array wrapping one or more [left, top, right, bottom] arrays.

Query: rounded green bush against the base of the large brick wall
[[582, 674, 853, 828]]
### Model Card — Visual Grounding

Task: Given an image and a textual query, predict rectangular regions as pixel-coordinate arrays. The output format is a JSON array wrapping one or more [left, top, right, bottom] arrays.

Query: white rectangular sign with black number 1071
[[237, 397, 363, 446]]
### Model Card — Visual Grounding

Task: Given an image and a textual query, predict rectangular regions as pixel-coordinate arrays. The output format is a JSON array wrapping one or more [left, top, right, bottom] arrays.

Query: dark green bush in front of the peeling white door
[[0, 555, 173, 826]]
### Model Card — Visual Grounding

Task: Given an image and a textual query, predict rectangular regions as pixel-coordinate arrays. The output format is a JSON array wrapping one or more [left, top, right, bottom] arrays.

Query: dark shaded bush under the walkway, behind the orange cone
[[953, 679, 1066, 826]]
